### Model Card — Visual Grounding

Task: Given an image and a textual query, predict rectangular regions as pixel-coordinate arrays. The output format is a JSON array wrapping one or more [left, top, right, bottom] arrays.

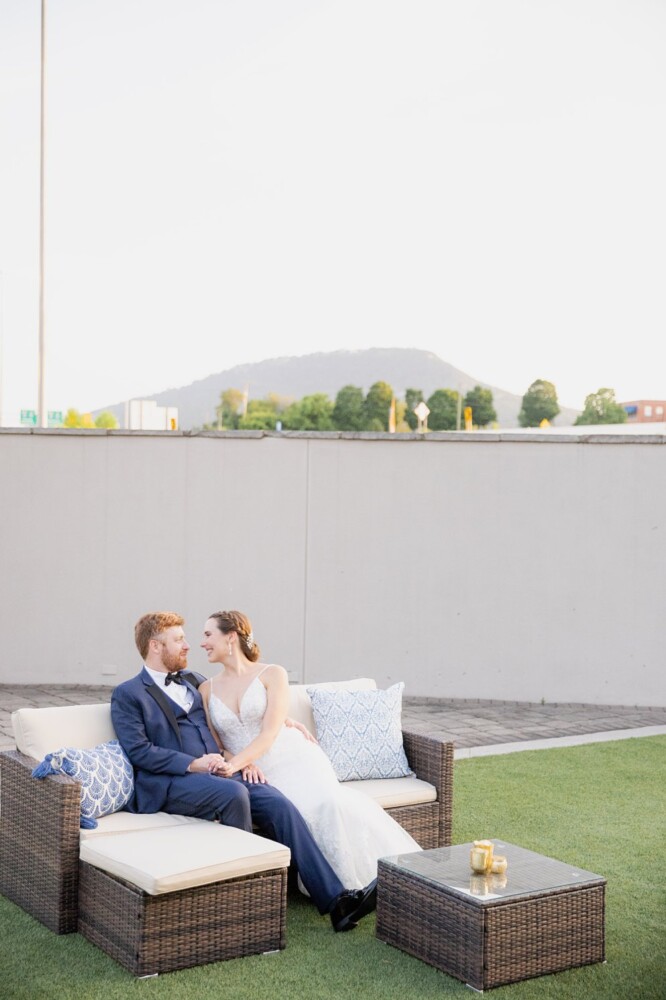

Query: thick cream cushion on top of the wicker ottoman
[[80, 822, 291, 896]]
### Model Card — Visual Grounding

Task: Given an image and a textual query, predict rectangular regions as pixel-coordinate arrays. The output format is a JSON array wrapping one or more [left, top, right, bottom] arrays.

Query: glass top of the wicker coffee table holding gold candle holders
[[382, 838, 606, 904]]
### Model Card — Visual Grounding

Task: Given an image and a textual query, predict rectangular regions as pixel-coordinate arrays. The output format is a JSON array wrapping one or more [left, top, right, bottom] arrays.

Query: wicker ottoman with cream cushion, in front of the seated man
[[78, 823, 290, 976]]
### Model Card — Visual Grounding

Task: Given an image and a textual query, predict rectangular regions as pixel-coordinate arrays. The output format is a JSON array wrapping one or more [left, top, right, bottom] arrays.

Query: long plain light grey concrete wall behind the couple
[[0, 430, 666, 705]]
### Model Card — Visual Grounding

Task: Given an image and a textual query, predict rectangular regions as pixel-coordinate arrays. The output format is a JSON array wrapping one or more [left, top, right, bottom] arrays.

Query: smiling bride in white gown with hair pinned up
[[199, 611, 420, 889]]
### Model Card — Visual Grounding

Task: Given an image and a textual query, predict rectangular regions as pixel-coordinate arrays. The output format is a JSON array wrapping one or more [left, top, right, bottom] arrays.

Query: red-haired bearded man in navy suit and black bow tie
[[111, 611, 377, 931]]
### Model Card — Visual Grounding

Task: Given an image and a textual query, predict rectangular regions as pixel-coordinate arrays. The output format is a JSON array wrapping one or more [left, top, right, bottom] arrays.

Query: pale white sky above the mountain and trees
[[0, 0, 666, 425]]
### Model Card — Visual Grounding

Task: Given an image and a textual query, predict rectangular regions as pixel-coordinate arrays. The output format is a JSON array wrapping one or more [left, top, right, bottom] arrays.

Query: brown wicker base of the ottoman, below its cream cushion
[[79, 862, 287, 976]]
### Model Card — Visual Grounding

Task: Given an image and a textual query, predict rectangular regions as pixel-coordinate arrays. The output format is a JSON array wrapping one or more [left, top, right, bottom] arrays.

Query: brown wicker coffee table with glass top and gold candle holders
[[377, 840, 606, 990]]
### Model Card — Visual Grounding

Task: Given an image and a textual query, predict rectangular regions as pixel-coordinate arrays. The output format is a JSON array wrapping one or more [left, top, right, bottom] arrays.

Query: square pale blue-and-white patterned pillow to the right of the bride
[[308, 683, 413, 781]]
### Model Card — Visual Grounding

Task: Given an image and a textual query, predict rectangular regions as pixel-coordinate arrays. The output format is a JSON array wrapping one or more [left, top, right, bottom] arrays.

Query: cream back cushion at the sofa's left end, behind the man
[[12, 705, 116, 760]]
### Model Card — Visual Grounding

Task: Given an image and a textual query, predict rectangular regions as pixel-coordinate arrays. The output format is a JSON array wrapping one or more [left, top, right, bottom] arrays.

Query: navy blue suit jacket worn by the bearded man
[[111, 668, 219, 813]]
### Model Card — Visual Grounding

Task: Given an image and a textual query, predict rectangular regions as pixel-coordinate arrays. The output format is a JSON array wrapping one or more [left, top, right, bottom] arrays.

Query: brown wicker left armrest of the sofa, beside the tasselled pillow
[[0, 751, 81, 934]]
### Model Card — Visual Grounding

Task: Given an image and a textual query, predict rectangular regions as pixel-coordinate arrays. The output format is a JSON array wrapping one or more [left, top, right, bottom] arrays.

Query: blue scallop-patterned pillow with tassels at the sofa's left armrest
[[32, 740, 134, 830]]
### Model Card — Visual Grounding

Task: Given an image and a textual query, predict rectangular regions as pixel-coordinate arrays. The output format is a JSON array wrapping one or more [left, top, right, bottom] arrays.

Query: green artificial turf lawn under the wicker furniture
[[0, 736, 666, 1000]]
